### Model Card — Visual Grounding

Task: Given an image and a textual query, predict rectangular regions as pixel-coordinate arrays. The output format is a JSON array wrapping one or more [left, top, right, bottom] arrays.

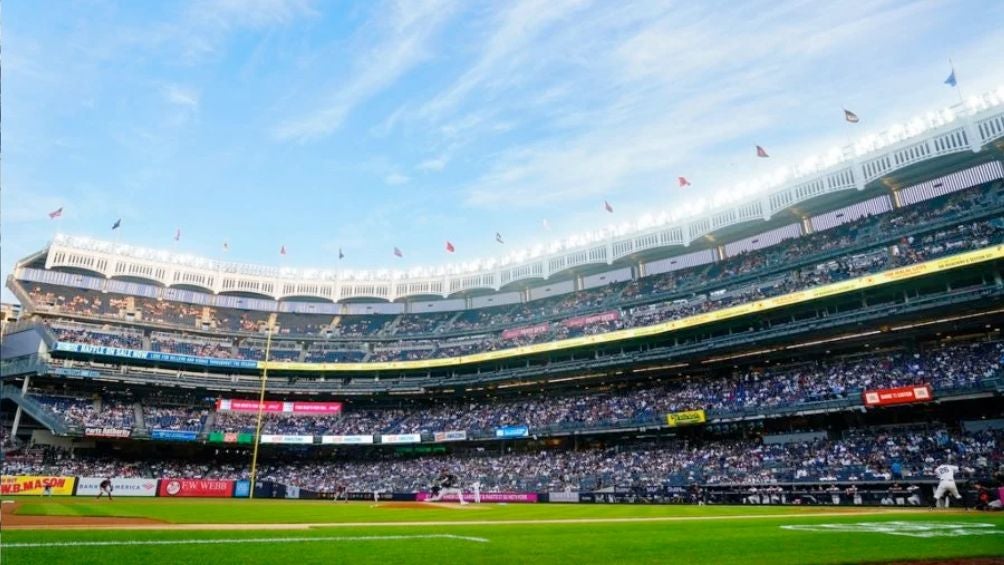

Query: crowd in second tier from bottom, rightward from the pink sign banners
[[191, 341, 1004, 436]]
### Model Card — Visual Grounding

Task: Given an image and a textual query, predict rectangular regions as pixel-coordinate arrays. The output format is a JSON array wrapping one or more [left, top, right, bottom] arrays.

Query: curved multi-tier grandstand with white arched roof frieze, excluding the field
[[0, 90, 1004, 505]]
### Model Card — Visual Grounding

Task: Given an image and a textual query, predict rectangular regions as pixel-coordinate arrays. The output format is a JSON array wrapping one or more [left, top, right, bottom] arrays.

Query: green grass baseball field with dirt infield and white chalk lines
[[0, 497, 1004, 565]]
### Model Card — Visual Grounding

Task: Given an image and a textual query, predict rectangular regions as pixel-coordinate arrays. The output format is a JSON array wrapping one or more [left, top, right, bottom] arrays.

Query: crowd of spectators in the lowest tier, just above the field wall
[[10, 423, 1004, 492]]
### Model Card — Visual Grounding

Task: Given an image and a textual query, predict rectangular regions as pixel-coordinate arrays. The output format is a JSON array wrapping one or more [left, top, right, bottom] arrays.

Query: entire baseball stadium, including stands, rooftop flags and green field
[[0, 1, 1004, 565]]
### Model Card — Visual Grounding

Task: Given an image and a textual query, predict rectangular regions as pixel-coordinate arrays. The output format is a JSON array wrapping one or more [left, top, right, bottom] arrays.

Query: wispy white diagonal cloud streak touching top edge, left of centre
[[273, 0, 454, 140]]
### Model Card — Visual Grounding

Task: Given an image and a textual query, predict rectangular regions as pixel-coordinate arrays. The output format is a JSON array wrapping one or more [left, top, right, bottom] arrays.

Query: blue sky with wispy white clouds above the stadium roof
[[0, 0, 1004, 300]]
